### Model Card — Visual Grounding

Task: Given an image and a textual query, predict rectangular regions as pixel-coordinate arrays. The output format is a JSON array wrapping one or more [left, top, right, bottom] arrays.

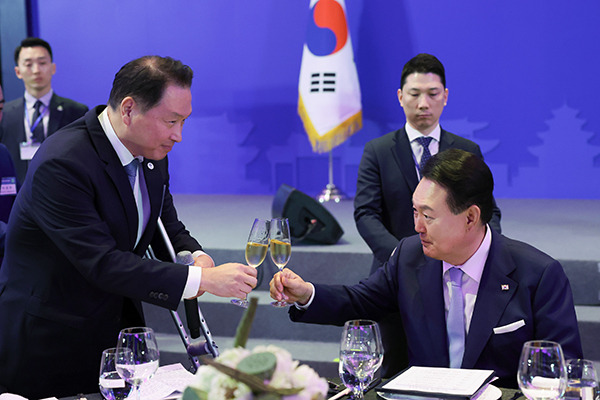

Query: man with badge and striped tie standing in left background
[[0, 38, 88, 184]]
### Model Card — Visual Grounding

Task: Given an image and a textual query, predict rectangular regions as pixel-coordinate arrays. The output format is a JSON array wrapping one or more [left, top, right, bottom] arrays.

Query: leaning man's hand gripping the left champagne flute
[[197, 263, 256, 299]]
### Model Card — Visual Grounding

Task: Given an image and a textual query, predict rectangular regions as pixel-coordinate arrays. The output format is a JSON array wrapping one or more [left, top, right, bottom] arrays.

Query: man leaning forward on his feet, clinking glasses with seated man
[[0, 56, 256, 398]]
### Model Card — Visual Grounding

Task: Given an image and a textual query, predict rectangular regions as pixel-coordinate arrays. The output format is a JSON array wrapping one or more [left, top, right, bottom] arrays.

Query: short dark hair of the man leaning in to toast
[[108, 56, 194, 112]]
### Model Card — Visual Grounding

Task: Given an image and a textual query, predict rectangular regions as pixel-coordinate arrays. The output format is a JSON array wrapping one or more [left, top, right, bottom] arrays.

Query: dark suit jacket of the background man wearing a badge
[[0, 93, 88, 184]]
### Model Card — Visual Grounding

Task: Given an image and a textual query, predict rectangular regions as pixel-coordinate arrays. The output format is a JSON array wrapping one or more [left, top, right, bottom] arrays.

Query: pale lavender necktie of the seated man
[[446, 267, 465, 368]]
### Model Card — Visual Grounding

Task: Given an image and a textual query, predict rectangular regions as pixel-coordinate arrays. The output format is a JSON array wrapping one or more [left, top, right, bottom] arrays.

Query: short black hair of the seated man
[[421, 149, 494, 224]]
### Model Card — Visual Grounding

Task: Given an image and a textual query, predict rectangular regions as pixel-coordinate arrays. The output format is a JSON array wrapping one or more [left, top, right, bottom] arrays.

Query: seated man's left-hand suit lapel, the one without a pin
[[417, 256, 450, 365]]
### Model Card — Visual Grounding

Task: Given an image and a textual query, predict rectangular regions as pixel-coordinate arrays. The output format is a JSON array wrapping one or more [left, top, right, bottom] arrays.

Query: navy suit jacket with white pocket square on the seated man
[[290, 232, 582, 387]]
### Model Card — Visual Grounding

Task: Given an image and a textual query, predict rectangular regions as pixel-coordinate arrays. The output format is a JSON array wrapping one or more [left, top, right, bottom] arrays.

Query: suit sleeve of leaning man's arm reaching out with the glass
[[25, 159, 188, 309]]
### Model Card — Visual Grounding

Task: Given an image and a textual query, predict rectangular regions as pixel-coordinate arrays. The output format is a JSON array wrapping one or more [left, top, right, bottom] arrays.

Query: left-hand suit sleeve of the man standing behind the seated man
[[354, 142, 398, 263]]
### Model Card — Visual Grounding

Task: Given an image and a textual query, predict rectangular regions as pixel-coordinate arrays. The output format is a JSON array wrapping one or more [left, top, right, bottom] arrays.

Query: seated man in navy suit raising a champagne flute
[[271, 149, 582, 387]]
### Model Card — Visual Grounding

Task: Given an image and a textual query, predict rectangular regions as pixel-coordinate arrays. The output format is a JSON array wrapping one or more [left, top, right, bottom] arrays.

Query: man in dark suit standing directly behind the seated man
[[354, 54, 500, 376]]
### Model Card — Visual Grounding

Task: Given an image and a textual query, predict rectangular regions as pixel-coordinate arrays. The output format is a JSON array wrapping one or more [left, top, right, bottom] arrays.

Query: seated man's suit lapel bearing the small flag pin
[[462, 232, 519, 368]]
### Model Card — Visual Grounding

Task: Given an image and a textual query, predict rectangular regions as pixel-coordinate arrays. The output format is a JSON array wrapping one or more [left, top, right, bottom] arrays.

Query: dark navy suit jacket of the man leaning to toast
[[0, 106, 201, 398]]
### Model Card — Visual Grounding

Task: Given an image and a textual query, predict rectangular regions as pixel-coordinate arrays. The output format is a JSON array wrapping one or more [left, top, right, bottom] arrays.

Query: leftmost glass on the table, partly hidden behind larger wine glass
[[98, 347, 133, 400]]
